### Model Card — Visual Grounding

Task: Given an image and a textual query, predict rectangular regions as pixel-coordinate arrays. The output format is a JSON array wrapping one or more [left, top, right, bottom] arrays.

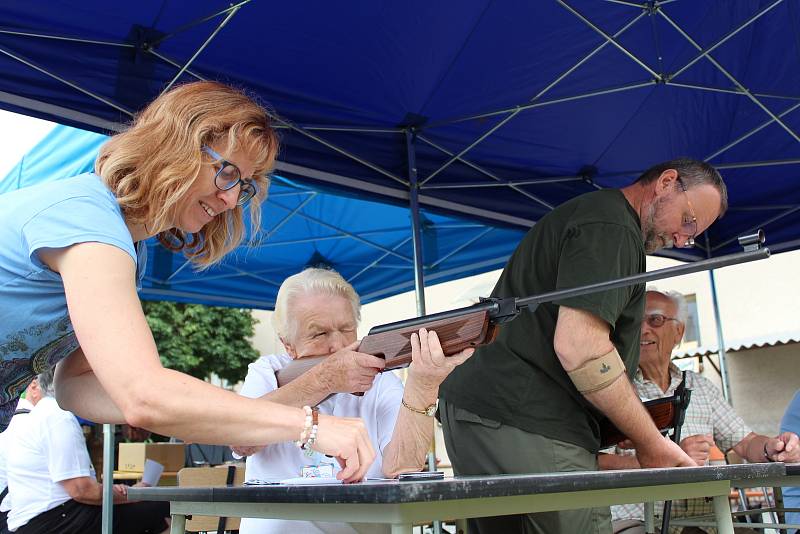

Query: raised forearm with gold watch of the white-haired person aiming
[[383, 383, 438, 478]]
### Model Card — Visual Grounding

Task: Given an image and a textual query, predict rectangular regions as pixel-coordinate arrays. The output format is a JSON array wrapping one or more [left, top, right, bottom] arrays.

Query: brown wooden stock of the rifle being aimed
[[277, 310, 499, 387]]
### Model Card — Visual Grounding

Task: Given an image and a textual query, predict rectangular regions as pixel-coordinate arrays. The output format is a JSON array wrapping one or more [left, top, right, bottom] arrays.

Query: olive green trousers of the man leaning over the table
[[439, 400, 611, 534]]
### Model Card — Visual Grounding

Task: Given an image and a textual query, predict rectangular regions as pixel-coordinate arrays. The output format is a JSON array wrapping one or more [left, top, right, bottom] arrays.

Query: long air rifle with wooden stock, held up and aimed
[[277, 230, 769, 386]]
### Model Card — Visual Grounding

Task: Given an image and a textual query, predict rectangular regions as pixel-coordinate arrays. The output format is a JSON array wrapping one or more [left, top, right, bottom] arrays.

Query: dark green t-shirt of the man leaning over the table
[[439, 189, 645, 452]]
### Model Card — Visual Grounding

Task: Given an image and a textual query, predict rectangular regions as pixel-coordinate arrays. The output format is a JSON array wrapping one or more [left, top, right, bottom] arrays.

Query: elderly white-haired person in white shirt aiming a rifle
[[234, 268, 473, 534]]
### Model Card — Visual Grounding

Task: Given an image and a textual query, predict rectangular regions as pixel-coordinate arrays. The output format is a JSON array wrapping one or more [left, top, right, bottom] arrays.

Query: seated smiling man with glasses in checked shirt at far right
[[598, 288, 800, 534]]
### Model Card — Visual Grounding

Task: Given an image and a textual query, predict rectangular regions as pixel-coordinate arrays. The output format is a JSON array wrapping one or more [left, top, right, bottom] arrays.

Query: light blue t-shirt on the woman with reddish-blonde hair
[[0, 174, 146, 429]]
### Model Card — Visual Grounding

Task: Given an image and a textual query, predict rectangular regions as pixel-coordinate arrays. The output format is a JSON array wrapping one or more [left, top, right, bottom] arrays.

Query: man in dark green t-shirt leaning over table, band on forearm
[[439, 159, 727, 534]]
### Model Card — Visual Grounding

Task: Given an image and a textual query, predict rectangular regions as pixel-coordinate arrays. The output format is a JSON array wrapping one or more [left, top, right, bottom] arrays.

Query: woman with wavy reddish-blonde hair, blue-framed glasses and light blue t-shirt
[[0, 82, 375, 481]]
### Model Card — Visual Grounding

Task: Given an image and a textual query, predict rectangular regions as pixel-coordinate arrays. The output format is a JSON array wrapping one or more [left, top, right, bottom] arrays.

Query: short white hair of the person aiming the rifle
[[272, 267, 361, 342]]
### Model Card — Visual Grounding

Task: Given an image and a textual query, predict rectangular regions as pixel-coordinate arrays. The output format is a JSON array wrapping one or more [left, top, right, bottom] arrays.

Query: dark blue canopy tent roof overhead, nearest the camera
[[0, 0, 800, 528]]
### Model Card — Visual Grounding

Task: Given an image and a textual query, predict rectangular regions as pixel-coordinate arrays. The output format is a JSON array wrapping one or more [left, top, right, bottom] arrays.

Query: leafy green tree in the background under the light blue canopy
[[142, 301, 258, 384]]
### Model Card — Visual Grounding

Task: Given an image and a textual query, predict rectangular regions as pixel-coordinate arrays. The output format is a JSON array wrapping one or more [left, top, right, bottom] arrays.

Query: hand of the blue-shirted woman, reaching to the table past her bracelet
[[314, 415, 375, 482]]
